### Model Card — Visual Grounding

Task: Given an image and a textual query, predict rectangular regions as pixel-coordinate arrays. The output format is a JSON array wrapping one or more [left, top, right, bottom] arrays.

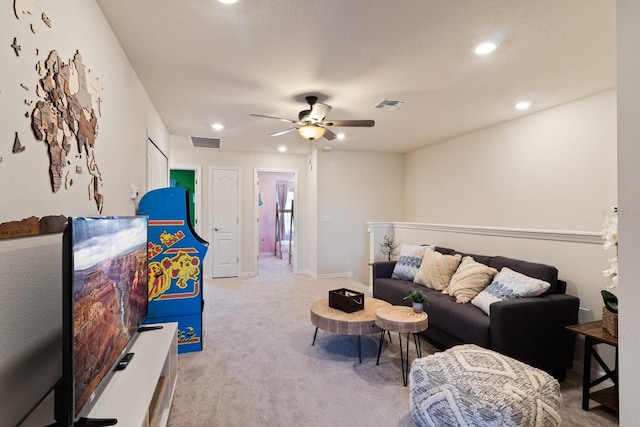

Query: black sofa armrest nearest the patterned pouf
[[490, 294, 580, 380]]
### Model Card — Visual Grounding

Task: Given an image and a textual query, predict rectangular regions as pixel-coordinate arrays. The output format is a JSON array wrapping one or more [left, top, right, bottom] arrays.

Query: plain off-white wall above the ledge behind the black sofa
[[405, 90, 616, 231]]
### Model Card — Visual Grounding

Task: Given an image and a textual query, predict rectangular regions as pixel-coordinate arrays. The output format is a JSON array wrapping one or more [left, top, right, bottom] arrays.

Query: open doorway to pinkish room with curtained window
[[255, 170, 297, 274]]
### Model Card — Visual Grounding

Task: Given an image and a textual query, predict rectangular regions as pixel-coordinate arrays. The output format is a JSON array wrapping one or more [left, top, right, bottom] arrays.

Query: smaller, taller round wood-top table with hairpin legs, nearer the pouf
[[376, 305, 429, 386]]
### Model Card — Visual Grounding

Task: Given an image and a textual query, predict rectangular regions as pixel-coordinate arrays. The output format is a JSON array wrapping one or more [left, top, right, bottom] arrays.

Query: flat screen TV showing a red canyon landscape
[[54, 216, 148, 426]]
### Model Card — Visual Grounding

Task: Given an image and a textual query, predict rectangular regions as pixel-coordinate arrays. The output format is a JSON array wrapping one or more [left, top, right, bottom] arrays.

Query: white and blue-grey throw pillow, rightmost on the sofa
[[471, 267, 551, 314]]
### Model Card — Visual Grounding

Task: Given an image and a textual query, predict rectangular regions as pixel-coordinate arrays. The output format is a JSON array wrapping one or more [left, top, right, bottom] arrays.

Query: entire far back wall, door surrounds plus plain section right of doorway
[[171, 145, 403, 283]]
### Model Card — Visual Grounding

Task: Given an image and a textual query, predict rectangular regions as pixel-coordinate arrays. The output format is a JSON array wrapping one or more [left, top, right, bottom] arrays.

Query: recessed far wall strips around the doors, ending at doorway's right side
[[170, 142, 309, 277]]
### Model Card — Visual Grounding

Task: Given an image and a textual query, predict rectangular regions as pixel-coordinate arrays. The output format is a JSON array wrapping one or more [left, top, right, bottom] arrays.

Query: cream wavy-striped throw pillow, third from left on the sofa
[[446, 256, 498, 304]]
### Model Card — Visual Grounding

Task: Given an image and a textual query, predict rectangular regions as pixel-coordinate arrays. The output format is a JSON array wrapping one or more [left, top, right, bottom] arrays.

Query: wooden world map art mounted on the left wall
[[0, 0, 104, 239]]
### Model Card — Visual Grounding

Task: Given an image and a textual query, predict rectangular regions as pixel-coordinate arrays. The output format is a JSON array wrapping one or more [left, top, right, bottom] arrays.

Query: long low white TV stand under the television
[[84, 323, 178, 427]]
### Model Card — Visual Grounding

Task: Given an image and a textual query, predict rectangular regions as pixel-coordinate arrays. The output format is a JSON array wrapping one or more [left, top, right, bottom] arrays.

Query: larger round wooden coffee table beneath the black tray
[[311, 297, 391, 363]]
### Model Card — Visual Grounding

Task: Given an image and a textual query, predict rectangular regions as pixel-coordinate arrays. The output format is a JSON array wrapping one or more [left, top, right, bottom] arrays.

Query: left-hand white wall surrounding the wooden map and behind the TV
[[0, 0, 169, 425]]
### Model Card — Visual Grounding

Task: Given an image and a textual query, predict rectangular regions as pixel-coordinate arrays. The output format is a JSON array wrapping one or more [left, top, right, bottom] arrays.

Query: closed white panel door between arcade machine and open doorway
[[211, 169, 240, 278]]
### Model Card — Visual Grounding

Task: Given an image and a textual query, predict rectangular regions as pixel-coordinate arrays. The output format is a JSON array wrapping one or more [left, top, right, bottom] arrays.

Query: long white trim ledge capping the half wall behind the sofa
[[367, 222, 602, 245]]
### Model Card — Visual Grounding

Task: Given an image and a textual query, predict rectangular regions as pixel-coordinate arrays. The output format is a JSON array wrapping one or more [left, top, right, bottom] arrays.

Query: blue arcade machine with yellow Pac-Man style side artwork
[[138, 187, 209, 353]]
